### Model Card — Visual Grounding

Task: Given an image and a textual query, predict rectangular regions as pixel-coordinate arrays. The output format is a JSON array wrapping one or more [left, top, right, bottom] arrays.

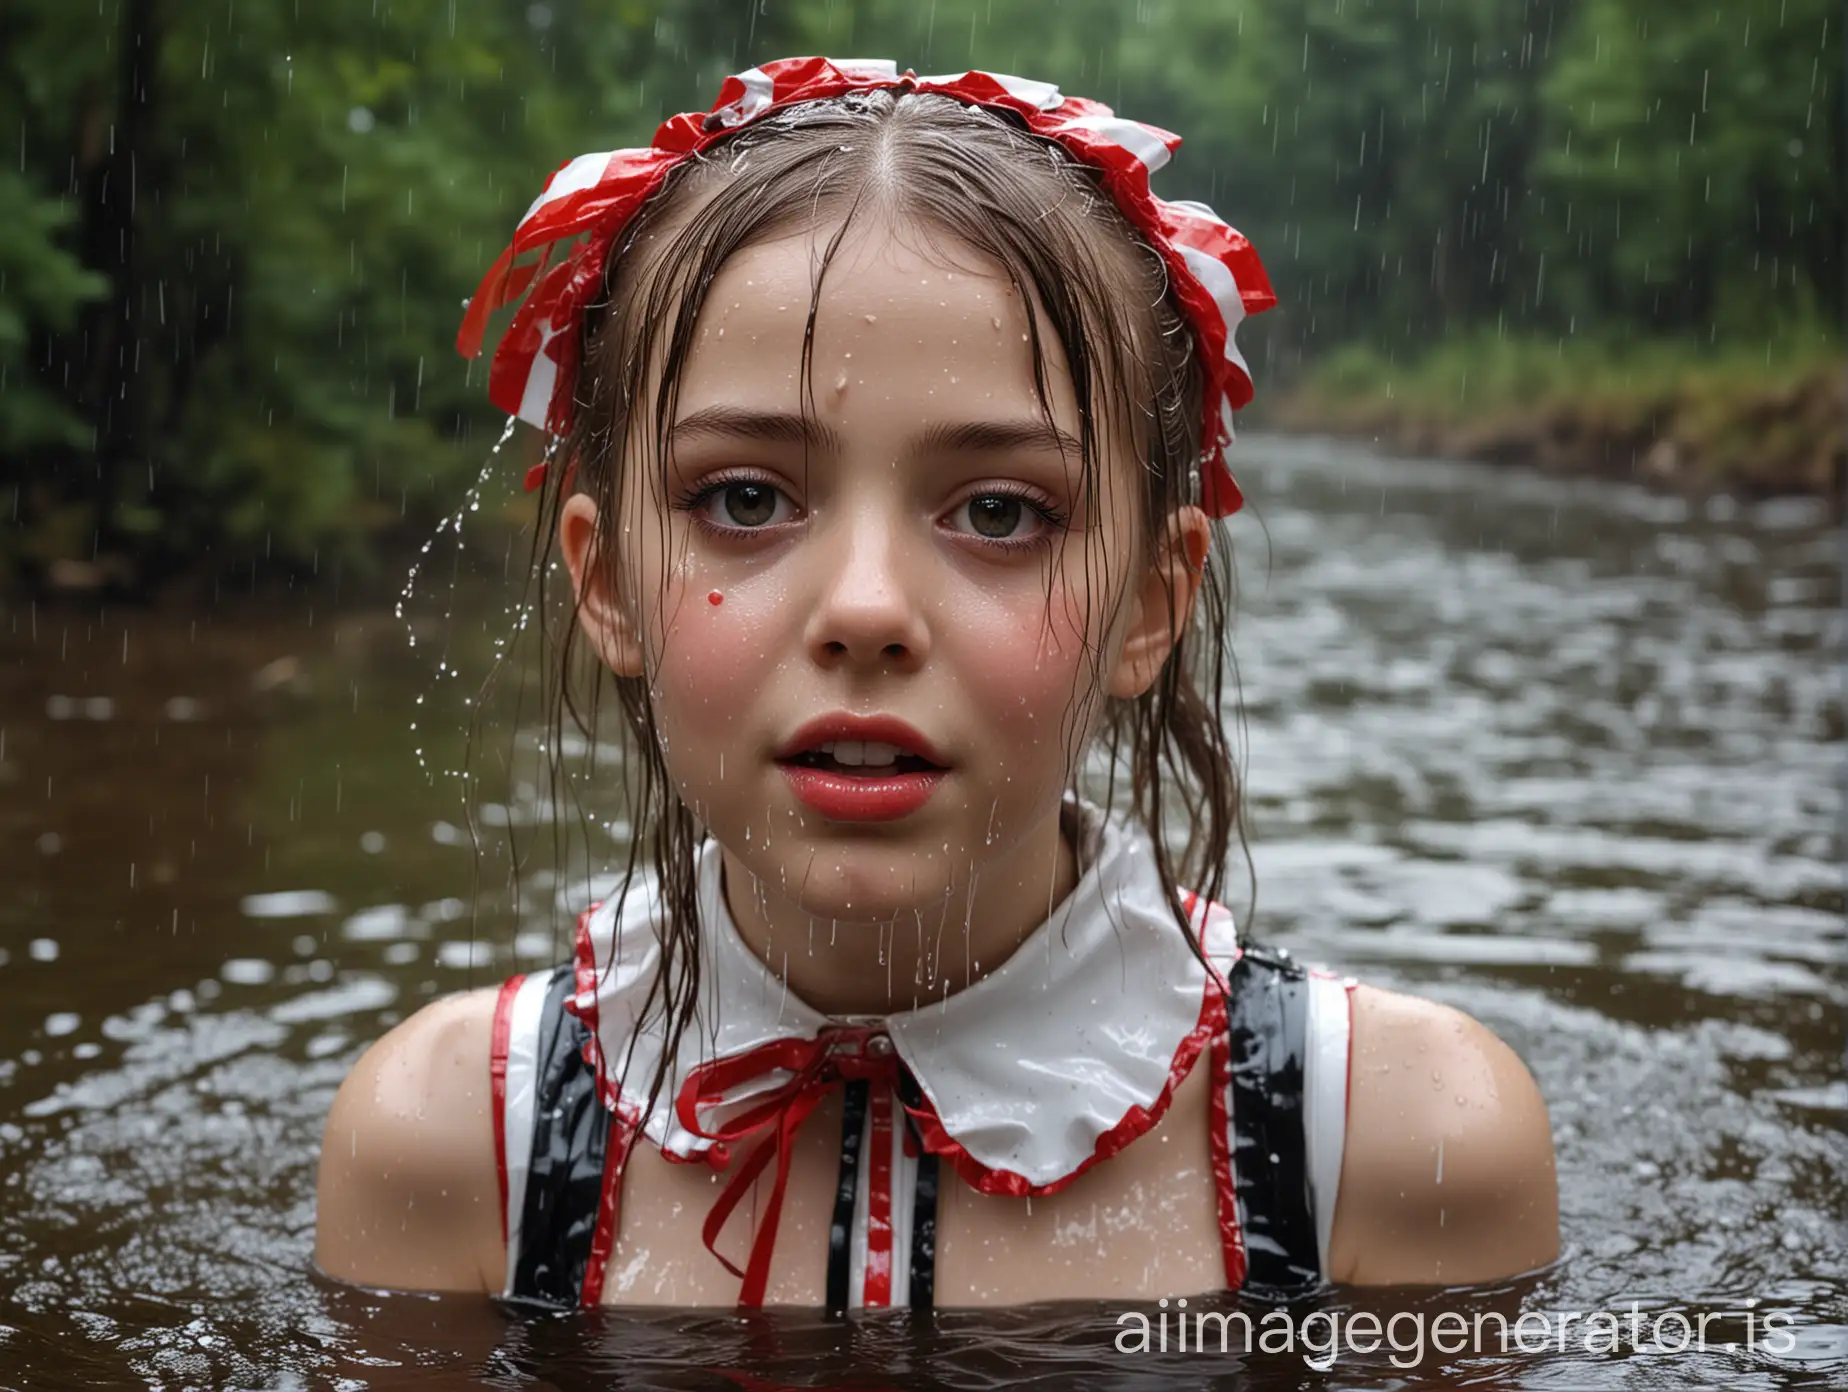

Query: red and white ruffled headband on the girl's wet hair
[[456, 57, 1277, 518]]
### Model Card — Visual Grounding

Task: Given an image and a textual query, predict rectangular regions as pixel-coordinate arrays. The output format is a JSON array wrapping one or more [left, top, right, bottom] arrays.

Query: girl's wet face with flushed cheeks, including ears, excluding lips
[[562, 227, 1205, 921]]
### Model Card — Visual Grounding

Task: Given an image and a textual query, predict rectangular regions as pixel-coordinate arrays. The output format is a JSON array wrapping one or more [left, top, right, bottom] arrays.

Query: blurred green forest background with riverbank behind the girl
[[0, 0, 1848, 590]]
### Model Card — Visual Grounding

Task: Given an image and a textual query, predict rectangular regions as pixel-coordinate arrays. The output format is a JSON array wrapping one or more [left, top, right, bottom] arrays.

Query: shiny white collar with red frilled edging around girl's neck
[[569, 795, 1236, 1192]]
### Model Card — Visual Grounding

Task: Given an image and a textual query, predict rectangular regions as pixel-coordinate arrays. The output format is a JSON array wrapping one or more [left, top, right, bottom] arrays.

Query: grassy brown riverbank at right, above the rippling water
[[1262, 335, 1848, 516]]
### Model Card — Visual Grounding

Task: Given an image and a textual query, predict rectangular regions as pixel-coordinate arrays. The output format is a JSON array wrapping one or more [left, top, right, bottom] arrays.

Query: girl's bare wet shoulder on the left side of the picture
[[314, 987, 505, 1290]]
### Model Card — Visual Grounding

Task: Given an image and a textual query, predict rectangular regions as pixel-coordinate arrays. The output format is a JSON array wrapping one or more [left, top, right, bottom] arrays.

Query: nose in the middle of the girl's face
[[808, 501, 930, 671]]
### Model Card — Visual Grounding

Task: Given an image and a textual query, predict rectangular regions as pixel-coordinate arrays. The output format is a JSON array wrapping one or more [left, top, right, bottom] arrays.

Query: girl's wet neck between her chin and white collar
[[723, 812, 1077, 1015]]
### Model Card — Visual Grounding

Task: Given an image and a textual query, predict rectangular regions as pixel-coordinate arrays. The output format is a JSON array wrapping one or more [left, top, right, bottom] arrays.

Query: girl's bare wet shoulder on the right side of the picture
[[1329, 987, 1560, 1285]]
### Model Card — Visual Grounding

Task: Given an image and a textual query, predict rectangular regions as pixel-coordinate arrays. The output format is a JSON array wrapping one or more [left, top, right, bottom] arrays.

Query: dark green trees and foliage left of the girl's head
[[0, 0, 805, 573]]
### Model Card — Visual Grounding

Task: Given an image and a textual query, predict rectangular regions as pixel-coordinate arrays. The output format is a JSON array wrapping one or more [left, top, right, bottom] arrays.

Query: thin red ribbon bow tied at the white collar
[[675, 1024, 909, 1305]]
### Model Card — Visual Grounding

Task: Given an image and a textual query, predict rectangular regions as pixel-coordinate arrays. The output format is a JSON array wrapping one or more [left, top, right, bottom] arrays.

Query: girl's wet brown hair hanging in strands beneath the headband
[[536, 91, 1242, 1107]]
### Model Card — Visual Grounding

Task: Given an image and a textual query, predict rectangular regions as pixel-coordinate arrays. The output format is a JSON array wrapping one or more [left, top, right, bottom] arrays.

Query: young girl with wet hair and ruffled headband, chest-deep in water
[[316, 59, 1558, 1309]]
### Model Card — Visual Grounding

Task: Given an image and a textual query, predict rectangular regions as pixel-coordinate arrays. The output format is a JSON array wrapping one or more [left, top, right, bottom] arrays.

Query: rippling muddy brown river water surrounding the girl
[[0, 440, 1848, 1388]]
